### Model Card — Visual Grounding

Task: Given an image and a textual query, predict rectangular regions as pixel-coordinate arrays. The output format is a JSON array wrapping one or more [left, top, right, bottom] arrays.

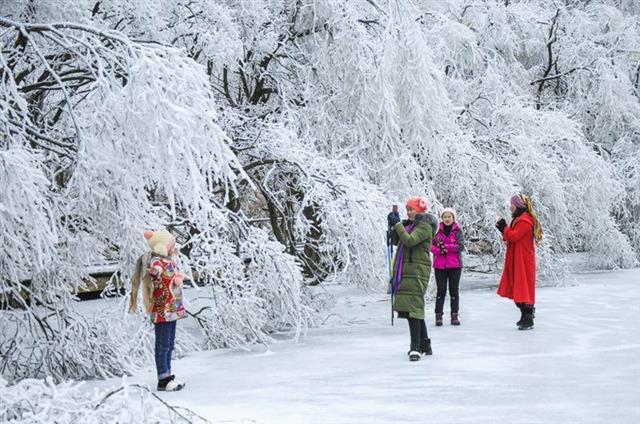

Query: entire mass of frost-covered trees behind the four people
[[0, 0, 640, 386]]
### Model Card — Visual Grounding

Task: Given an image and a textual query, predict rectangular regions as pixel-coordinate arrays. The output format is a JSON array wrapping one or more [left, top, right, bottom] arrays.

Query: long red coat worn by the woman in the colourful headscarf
[[498, 212, 536, 305]]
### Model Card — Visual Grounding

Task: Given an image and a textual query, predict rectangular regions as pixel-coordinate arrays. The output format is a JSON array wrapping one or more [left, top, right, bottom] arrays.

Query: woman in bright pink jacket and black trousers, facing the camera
[[431, 208, 464, 327]]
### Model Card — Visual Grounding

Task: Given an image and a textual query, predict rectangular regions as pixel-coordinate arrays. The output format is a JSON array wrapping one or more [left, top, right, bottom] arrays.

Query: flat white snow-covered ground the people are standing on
[[89, 270, 640, 424]]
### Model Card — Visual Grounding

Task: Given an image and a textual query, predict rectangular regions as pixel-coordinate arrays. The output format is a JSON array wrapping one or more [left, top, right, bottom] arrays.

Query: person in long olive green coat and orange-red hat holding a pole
[[392, 197, 438, 361]]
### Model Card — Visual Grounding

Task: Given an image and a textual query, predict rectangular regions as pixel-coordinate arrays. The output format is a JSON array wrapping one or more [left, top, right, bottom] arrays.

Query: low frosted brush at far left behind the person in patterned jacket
[[0, 302, 201, 382]]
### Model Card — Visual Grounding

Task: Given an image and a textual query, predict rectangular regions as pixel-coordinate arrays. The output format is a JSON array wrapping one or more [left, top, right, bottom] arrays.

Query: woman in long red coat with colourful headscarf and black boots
[[496, 194, 542, 330]]
